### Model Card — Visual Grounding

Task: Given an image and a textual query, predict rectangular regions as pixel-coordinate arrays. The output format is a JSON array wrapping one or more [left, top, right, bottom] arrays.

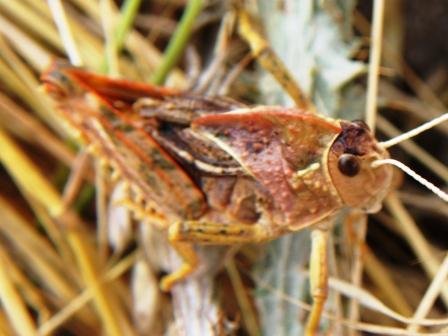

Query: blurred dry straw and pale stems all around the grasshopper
[[0, 0, 448, 335]]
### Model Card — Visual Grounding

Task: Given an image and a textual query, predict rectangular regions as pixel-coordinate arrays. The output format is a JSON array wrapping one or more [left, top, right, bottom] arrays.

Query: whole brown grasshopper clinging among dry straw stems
[[42, 62, 392, 335]]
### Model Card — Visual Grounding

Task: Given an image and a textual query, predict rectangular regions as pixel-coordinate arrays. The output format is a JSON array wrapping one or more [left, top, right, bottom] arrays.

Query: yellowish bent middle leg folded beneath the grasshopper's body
[[160, 221, 272, 291]]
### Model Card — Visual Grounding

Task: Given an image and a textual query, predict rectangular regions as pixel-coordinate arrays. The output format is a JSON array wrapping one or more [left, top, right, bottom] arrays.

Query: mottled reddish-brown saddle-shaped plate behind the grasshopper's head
[[192, 107, 341, 232]]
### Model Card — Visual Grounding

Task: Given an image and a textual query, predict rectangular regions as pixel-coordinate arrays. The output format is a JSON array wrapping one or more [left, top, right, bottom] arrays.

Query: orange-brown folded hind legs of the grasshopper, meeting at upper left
[[42, 63, 206, 220]]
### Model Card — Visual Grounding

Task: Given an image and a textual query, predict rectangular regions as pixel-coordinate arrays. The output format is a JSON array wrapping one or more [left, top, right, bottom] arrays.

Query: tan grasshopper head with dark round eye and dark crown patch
[[328, 121, 393, 212]]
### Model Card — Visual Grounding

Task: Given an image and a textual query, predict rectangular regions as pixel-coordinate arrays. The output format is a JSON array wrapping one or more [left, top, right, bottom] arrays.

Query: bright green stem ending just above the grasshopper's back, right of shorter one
[[152, 0, 202, 85]]
